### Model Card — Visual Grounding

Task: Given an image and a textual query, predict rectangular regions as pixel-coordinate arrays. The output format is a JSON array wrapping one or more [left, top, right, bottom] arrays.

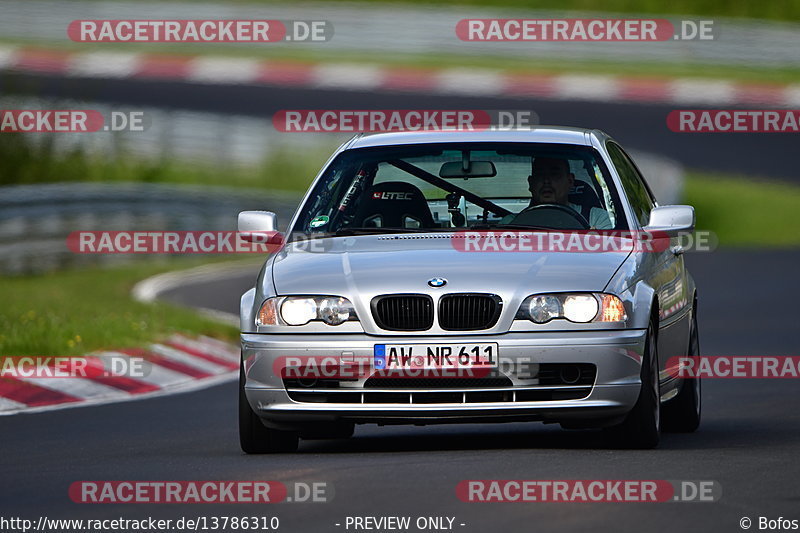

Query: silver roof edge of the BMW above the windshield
[[346, 126, 605, 150]]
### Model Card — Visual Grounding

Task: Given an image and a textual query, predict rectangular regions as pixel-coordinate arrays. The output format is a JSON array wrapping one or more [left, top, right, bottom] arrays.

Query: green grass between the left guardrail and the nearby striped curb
[[0, 260, 244, 356]]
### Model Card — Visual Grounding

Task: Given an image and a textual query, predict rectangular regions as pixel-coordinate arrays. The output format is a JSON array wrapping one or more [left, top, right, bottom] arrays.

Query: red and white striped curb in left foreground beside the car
[[0, 335, 240, 415]]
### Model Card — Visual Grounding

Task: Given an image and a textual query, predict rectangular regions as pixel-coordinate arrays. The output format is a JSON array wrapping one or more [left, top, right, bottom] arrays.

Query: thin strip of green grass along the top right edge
[[61, 0, 800, 20]]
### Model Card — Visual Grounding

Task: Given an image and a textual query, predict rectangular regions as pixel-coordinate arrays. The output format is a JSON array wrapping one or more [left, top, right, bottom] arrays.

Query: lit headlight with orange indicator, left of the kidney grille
[[256, 296, 358, 326]]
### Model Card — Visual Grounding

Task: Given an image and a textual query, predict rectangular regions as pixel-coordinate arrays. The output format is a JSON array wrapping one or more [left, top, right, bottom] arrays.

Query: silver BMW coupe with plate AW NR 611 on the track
[[239, 127, 701, 453]]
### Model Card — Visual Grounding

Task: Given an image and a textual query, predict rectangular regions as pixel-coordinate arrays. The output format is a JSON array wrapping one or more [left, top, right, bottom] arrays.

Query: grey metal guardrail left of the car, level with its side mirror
[[0, 183, 298, 275]]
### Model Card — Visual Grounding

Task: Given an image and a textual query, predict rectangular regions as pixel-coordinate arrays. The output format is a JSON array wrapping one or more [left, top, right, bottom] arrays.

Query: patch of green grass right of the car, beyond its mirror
[[684, 172, 800, 247]]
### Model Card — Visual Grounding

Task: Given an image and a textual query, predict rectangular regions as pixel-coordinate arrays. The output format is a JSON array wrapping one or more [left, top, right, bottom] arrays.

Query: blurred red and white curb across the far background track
[[0, 46, 800, 107]]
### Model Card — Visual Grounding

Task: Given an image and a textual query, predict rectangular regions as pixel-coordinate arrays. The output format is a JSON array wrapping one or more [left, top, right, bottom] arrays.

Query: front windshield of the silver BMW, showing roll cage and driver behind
[[293, 143, 627, 236]]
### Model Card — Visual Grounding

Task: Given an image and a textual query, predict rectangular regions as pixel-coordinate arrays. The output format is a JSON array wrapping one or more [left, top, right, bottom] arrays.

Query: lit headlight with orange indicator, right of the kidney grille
[[516, 293, 627, 324]]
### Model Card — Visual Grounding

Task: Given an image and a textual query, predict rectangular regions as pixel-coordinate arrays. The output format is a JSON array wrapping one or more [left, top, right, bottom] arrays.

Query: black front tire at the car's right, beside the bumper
[[605, 321, 661, 449]]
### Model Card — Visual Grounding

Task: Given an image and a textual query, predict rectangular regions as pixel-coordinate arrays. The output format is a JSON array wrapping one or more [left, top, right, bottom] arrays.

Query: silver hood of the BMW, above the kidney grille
[[272, 234, 630, 300]]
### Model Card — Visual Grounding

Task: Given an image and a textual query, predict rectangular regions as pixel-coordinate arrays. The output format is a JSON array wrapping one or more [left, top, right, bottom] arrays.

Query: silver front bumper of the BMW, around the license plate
[[241, 329, 646, 428]]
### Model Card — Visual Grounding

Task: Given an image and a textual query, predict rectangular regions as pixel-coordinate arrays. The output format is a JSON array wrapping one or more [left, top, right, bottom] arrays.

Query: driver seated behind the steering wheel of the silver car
[[503, 157, 613, 229]]
